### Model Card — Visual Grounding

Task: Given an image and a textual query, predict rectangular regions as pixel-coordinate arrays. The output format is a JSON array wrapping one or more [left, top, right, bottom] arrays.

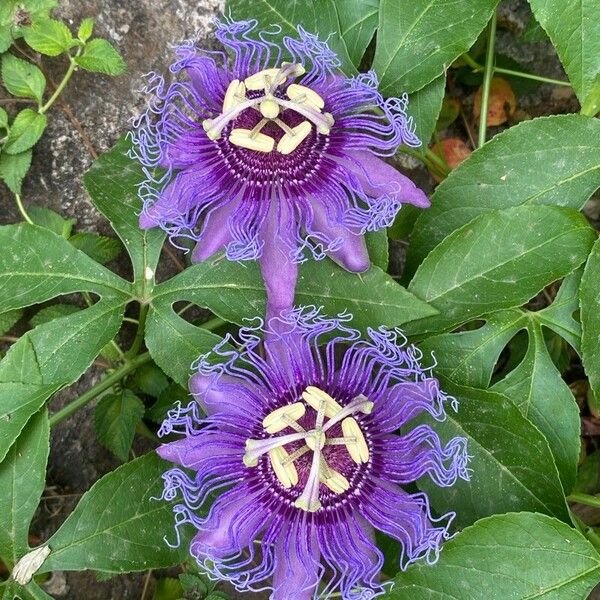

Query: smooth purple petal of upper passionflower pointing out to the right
[[348, 151, 431, 208]]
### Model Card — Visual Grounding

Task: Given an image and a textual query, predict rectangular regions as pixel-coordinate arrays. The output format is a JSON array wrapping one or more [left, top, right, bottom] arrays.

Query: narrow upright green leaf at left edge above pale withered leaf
[[0, 409, 50, 569]]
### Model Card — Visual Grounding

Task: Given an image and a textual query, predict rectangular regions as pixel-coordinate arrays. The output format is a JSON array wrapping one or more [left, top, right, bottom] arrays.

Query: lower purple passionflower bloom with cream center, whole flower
[[158, 308, 468, 600]]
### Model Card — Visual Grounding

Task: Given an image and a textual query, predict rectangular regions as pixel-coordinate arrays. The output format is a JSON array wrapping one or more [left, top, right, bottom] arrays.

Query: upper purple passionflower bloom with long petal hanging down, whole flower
[[133, 20, 429, 314]]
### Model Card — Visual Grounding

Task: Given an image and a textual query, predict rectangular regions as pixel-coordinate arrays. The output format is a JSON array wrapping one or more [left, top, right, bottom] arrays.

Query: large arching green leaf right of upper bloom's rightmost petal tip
[[407, 115, 600, 273]]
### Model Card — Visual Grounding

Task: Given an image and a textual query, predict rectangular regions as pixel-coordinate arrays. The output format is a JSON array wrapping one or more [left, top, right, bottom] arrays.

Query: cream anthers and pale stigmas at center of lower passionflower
[[244, 386, 373, 512]]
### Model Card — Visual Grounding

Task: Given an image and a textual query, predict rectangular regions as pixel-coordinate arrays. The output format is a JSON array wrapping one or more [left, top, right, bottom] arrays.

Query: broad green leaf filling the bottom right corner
[[390, 513, 600, 600]]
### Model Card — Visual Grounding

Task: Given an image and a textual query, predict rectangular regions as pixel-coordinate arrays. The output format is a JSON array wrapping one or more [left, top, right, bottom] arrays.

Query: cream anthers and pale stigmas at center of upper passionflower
[[202, 63, 334, 154]]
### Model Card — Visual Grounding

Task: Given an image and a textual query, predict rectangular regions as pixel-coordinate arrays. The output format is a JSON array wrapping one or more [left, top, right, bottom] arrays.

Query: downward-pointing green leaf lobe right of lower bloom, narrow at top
[[491, 321, 581, 493]]
